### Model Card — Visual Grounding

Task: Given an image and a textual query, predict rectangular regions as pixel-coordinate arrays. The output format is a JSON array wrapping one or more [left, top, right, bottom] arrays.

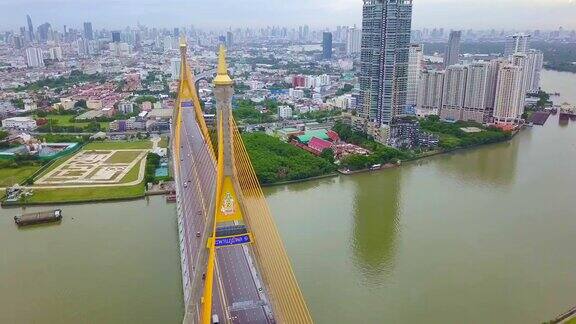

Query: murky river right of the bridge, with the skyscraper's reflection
[[266, 71, 576, 323]]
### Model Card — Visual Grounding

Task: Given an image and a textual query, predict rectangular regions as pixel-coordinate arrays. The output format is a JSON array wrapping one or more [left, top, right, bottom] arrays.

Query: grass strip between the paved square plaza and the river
[[28, 183, 144, 203]]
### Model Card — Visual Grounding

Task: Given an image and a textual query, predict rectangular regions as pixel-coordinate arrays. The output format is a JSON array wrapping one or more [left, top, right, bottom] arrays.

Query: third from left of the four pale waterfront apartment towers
[[461, 62, 490, 123]]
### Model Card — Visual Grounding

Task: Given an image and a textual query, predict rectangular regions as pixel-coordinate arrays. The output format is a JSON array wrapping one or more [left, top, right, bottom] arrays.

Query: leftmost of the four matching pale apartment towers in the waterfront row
[[416, 70, 444, 117]]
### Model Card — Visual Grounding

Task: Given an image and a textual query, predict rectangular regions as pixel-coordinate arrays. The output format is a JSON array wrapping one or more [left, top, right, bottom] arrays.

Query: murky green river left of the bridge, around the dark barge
[[0, 197, 184, 324]]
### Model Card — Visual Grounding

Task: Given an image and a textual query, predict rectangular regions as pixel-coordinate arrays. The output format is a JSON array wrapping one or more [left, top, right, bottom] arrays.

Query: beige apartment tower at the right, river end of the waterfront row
[[494, 64, 524, 124]]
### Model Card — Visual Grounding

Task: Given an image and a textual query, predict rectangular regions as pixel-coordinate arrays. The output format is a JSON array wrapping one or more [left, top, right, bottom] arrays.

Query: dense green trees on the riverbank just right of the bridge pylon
[[242, 133, 336, 184]]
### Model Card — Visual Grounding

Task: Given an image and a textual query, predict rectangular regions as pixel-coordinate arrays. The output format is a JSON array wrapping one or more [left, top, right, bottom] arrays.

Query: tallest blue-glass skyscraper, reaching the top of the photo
[[359, 0, 412, 126]]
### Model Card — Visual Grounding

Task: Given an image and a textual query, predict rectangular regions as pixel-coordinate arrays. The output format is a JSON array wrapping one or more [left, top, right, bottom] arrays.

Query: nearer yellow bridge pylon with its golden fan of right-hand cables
[[201, 46, 312, 324]]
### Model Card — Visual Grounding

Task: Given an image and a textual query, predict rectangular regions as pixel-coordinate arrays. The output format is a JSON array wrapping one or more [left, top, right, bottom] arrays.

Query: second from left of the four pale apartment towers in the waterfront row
[[440, 64, 468, 120]]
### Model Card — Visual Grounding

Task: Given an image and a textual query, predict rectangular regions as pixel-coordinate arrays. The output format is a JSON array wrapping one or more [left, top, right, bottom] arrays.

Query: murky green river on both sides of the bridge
[[0, 71, 576, 324]]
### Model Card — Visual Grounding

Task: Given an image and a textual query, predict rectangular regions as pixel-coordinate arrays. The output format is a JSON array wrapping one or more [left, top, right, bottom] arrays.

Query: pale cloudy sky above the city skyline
[[0, 0, 576, 30]]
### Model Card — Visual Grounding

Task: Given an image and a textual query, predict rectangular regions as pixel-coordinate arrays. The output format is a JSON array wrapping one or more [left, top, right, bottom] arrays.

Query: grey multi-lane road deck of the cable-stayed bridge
[[178, 108, 274, 324]]
